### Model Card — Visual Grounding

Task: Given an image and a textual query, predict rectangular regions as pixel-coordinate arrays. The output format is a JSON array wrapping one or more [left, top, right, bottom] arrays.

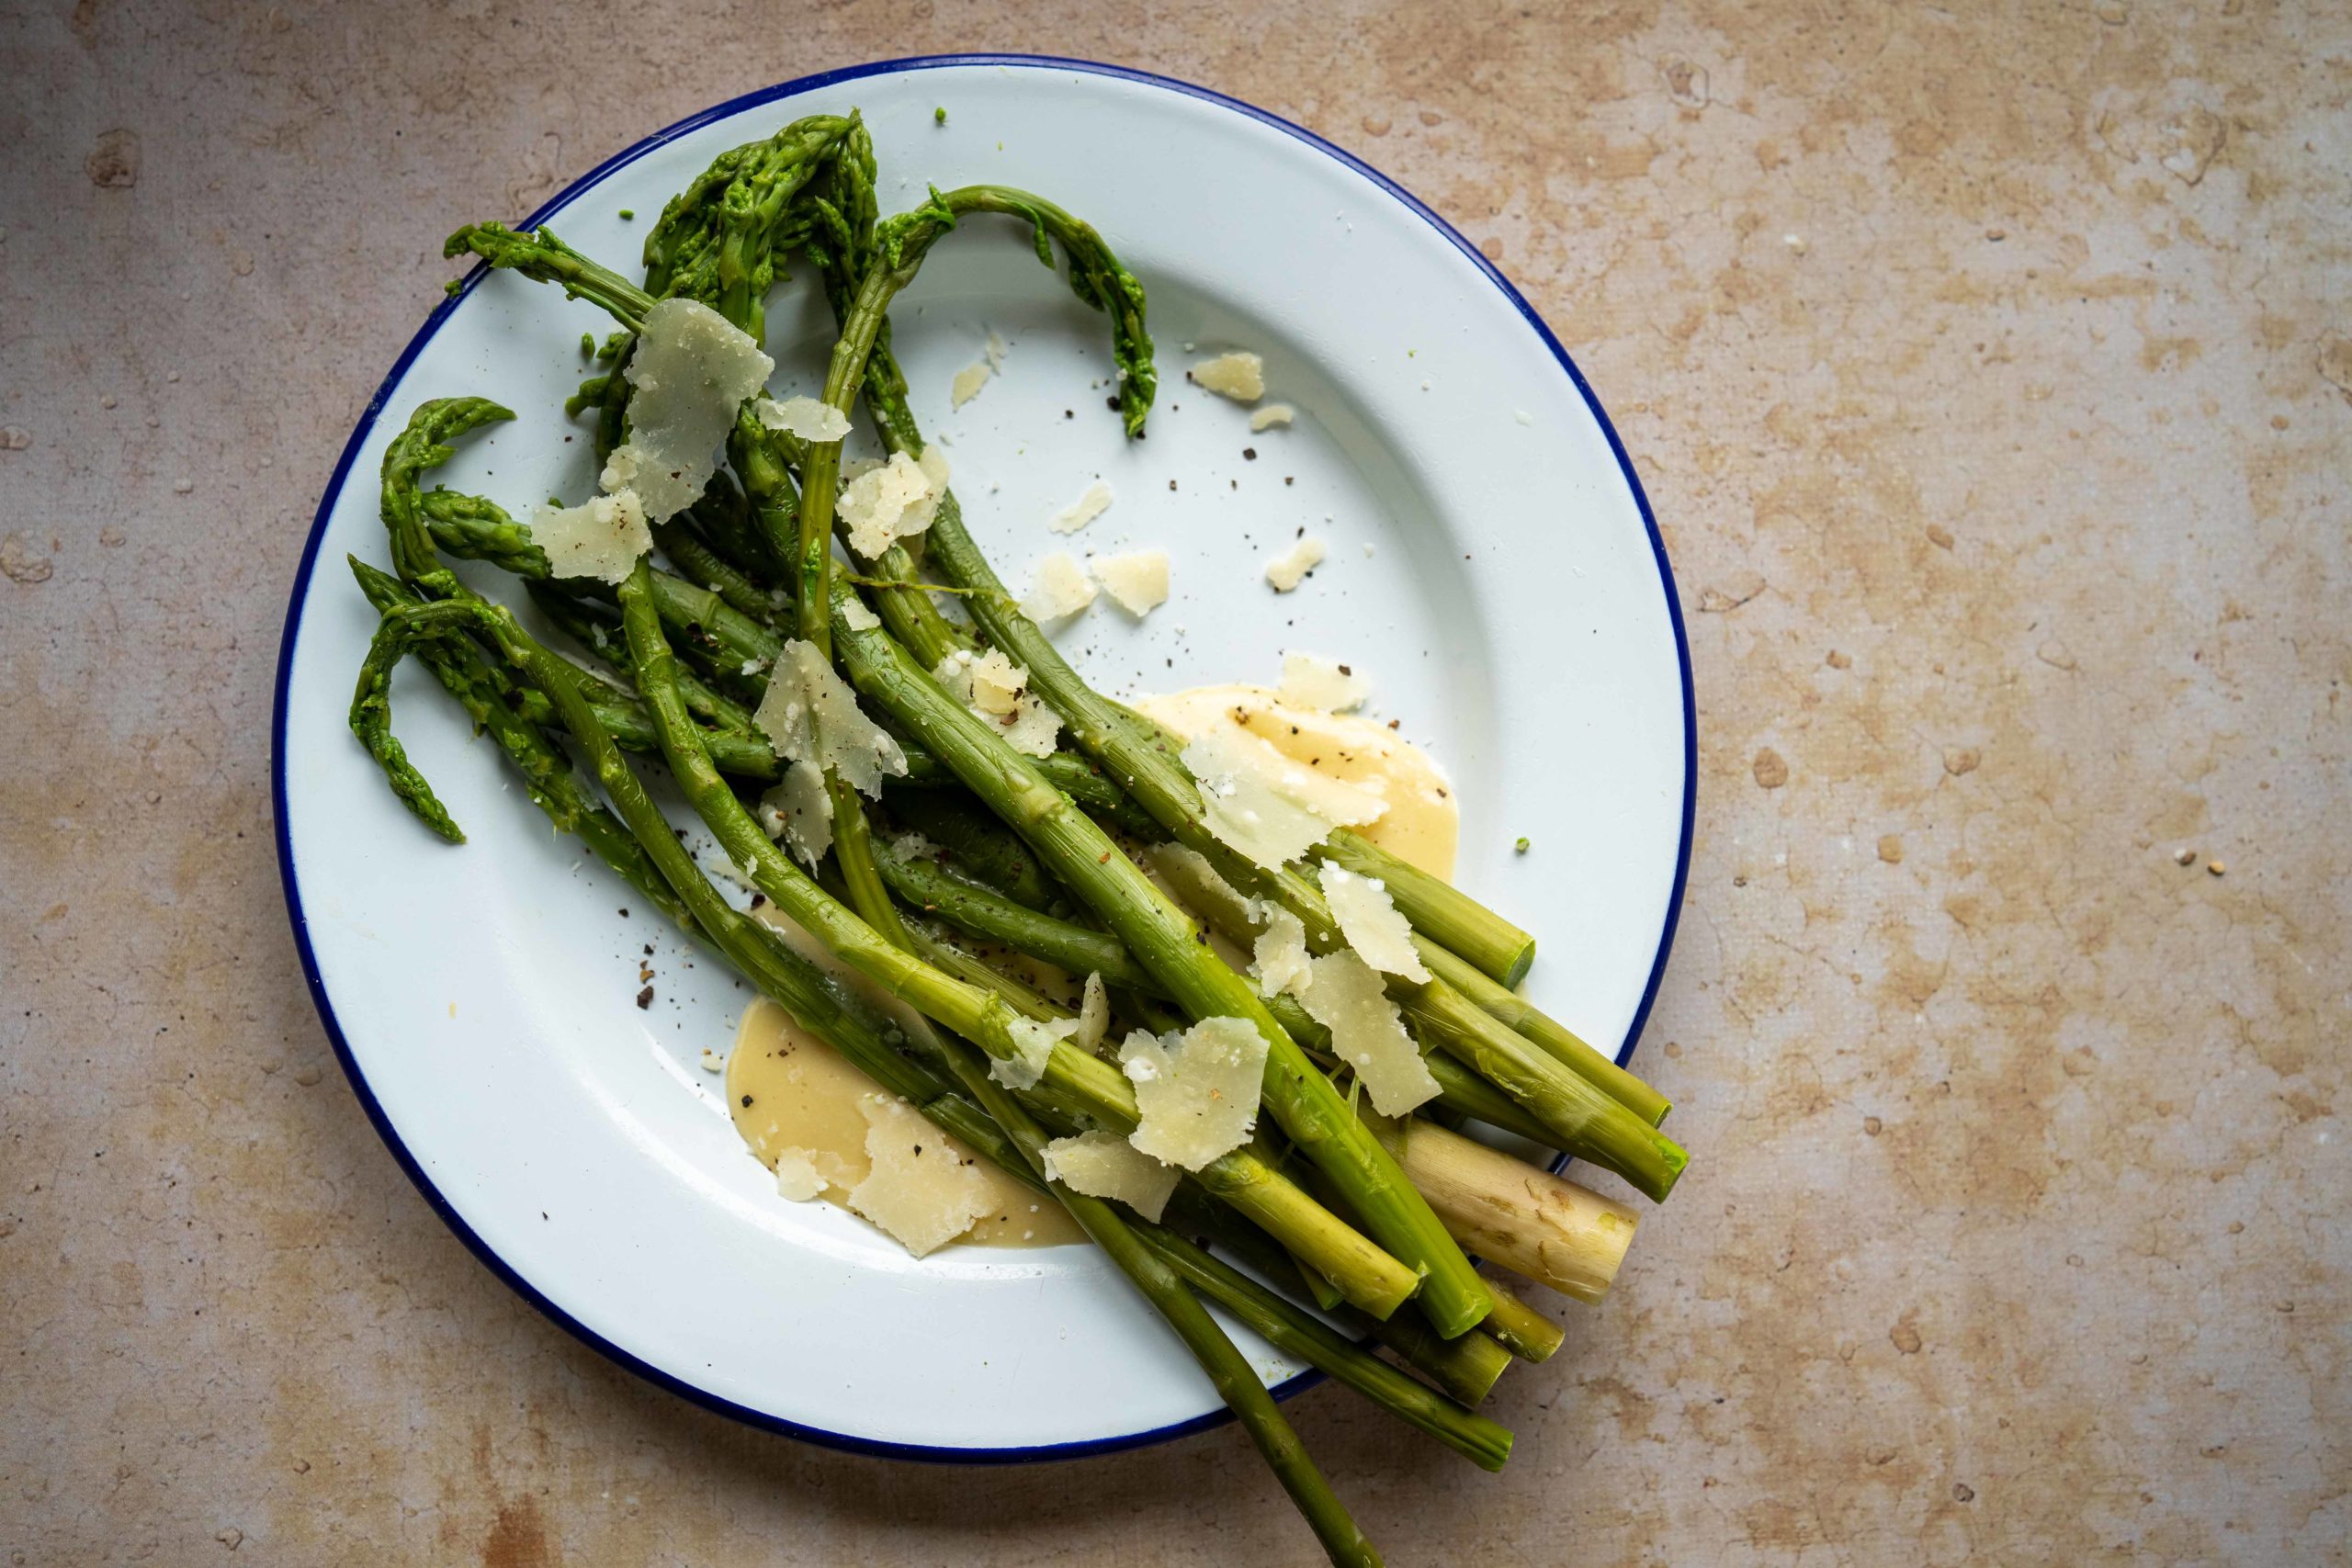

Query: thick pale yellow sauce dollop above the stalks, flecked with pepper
[[1129, 686, 1463, 877]]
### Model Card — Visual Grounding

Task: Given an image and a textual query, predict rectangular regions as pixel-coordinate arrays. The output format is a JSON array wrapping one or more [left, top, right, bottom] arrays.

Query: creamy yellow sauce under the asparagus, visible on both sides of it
[[727, 686, 1461, 1246]]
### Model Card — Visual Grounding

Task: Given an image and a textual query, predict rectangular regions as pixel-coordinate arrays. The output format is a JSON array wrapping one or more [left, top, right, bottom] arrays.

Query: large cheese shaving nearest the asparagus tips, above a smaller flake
[[605, 299, 776, 522]]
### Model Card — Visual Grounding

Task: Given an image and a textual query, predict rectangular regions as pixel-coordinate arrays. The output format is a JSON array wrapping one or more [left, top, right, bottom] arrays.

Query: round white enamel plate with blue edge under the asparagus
[[277, 59, 1693, 1460]]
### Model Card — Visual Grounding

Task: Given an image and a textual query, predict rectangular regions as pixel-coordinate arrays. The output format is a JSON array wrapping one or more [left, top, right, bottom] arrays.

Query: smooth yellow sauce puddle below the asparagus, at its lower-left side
[[727, 997, 1087, 1246]]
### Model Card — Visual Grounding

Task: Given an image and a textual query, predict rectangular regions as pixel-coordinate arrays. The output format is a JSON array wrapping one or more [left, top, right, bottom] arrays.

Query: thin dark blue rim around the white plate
[[270, 54, 1698, 1464]]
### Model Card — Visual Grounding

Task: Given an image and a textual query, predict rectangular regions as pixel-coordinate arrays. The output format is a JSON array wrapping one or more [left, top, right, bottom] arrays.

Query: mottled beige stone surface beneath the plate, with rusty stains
[[0, 0, 2352, 1568]]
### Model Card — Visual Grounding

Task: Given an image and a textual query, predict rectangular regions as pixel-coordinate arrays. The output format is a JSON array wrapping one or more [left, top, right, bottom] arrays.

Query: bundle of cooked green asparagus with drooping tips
[[350, 113, 1684, 1563]]
